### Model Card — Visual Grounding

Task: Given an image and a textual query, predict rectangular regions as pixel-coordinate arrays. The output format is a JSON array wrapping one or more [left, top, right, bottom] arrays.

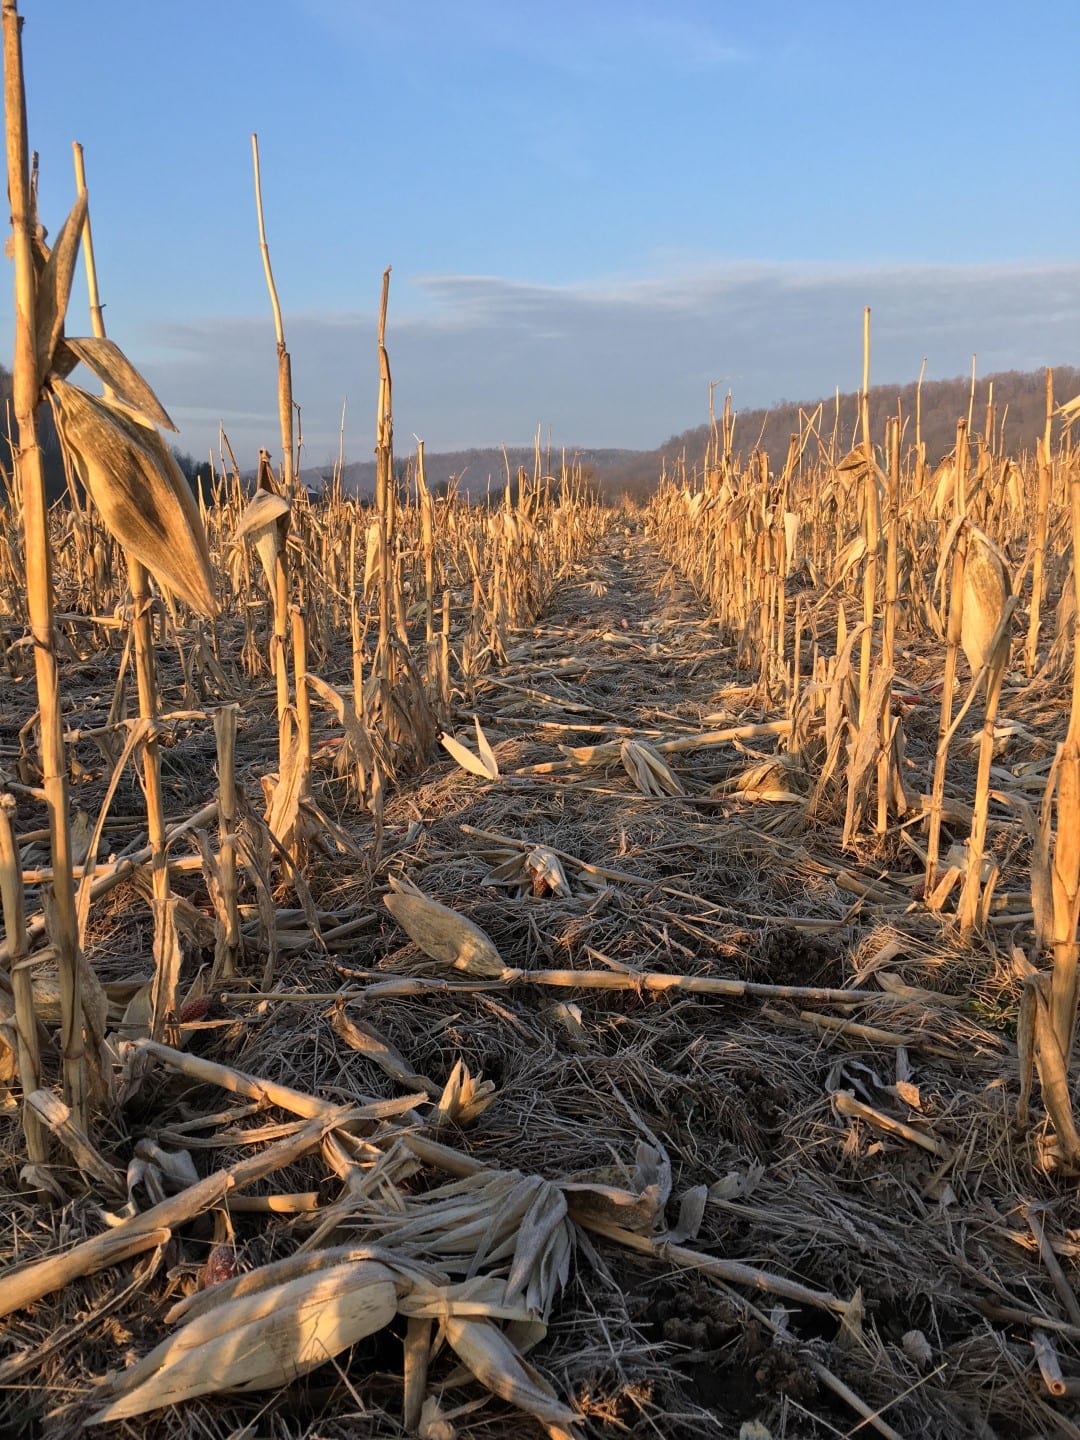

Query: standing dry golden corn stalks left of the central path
[[0, 0, 605, 1168]]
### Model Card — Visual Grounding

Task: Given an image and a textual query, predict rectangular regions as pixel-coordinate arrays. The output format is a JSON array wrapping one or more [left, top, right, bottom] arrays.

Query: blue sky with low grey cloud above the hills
[[8, 0, 1080, 464]]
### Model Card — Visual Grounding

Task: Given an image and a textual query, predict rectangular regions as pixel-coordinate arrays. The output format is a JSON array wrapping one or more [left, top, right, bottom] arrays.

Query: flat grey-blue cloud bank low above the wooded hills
[[143, 262, 1080, 464]]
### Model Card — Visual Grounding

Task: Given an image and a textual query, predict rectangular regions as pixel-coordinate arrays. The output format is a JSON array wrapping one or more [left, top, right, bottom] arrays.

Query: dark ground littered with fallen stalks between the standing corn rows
[[0, 489, 1077, 1436]]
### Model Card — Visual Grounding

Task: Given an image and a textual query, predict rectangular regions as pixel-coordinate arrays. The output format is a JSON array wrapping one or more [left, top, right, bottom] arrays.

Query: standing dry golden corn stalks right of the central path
[[649, 345, 1080, 1162]]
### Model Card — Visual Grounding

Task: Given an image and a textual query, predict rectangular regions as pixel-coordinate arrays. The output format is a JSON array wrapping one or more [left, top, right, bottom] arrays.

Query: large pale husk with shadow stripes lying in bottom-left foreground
[[88, 1261, 397, 1424]]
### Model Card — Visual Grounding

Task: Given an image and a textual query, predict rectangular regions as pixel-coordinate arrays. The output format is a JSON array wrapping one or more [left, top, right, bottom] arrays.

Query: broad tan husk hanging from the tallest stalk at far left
[[50, 379, 216, 616]]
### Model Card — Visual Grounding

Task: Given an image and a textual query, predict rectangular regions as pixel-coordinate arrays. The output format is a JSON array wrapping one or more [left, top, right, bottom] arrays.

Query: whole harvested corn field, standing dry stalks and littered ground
[[0, 0, 1080, 1440]]
